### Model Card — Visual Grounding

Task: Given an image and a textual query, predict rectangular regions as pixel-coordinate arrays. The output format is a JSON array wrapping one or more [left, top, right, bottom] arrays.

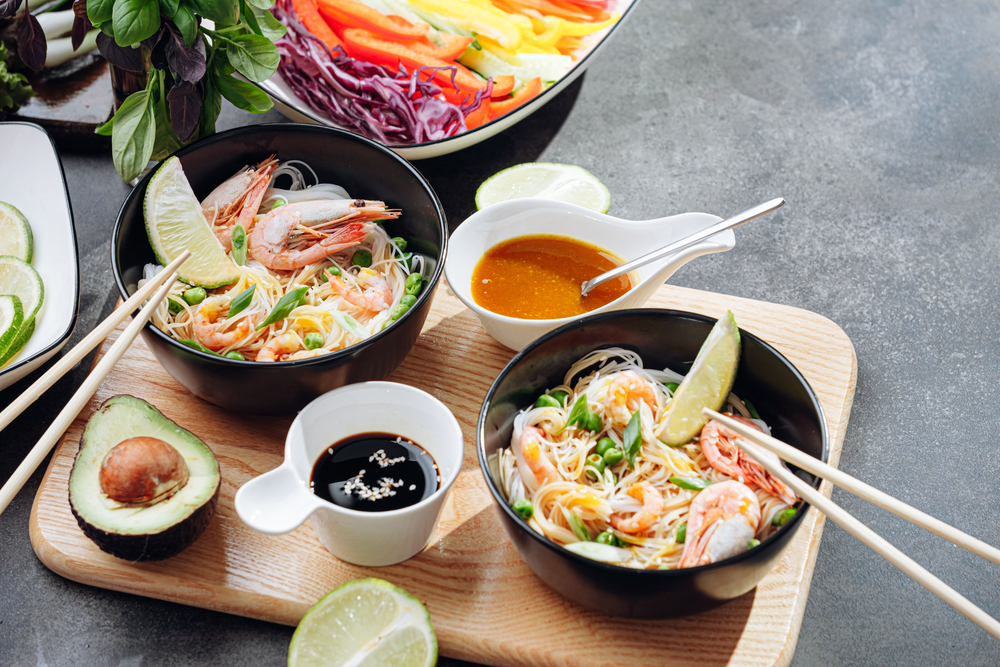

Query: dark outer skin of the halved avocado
[[69, 394, 222, 562]]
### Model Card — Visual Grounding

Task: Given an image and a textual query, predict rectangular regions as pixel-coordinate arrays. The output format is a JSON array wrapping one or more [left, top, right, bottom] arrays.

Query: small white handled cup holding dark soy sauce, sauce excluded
[[236, 382, 464, 567]]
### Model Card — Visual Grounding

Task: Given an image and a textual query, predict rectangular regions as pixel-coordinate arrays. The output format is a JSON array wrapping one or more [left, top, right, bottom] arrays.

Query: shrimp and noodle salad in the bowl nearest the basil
[[143, 156, 423, 362]]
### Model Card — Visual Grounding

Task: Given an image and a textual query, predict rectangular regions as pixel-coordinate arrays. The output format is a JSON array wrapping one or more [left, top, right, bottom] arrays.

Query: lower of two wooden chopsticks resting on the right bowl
[[702, 408, 1000, 639]]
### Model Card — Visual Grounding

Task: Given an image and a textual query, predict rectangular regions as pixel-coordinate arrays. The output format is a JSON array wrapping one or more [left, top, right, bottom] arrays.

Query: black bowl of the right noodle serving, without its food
[[476, 309, 827, 618]]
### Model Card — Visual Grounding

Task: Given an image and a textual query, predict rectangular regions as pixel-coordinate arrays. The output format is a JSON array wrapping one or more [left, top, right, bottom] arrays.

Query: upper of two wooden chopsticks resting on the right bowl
[[705, 410, 1000, 565]]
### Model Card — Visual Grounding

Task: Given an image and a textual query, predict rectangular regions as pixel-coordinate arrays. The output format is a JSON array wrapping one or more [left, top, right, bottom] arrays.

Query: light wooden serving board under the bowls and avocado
[[31, 281, 857, 667]]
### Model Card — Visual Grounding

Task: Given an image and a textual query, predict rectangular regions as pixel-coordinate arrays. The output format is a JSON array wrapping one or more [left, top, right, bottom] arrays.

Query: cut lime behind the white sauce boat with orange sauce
[[476, 162, 611, 213]]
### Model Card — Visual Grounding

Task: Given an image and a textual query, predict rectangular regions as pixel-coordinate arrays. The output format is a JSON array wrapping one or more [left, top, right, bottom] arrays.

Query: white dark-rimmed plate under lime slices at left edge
[[0, 123, 80, 389]]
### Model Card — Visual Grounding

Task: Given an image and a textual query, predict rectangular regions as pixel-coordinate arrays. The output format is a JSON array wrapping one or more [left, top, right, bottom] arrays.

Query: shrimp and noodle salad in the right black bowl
[[490, 348, 798, 569]]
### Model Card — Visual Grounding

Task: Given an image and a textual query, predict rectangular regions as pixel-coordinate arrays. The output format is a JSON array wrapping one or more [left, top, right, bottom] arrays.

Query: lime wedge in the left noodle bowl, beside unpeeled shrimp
[[143, 157, 240, 289]]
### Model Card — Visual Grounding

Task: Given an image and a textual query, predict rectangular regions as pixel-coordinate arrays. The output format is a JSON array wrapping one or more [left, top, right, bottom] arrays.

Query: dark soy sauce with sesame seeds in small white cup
[[309, 433, 441, 512]]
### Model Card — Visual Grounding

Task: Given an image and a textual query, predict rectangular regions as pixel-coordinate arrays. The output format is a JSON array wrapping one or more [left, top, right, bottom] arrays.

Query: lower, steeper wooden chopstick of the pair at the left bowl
[[0, 264, 184, 513]]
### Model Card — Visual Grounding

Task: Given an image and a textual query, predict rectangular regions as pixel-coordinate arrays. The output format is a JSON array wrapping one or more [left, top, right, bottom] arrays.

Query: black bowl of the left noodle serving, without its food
[[111, 124, 448, 414]]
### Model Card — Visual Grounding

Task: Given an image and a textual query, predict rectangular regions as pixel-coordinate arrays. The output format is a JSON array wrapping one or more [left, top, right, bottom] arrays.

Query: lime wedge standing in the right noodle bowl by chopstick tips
[[656, 311, 740, 446]]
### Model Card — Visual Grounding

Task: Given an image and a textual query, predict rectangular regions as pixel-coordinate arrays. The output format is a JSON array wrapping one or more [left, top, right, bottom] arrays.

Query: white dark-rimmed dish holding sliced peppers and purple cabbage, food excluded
[[250, 0, 639, 160]]
